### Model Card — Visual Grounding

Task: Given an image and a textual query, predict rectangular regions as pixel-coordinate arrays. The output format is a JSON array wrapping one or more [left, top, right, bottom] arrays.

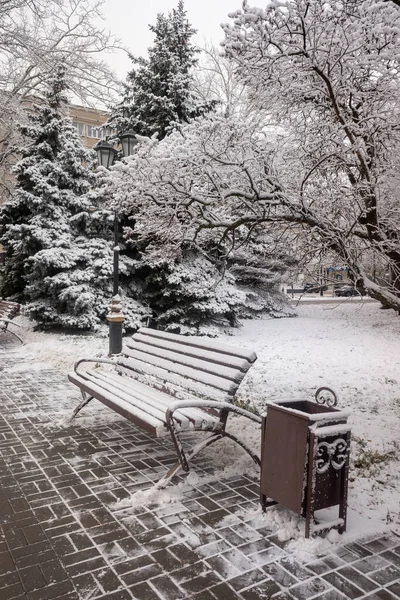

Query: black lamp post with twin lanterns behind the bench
[[94, 131, 137, 354]]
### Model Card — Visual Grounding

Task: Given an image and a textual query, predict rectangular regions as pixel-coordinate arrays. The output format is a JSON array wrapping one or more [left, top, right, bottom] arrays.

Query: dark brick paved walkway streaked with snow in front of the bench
[[0, 340, 400, 600]]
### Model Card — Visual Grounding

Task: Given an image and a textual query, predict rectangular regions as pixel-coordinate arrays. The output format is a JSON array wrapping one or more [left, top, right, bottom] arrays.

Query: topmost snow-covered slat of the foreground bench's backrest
[[125, 330, 253, 372]]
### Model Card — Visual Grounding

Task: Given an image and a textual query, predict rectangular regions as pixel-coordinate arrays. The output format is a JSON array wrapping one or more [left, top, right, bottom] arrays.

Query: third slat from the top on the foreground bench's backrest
[[118, 350, 239, 397]]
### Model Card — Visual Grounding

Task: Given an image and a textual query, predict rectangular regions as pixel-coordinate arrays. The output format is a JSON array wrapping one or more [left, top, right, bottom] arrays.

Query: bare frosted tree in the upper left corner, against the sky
[[0, 0, 119, 204]]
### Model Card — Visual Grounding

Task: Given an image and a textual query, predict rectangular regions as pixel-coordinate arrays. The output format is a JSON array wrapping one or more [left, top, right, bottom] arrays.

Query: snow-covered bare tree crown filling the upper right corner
[[224, 0, 400, 310]]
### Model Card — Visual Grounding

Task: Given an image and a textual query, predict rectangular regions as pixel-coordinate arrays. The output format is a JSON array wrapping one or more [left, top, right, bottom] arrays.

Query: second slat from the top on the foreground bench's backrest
[[124, 344, 244, 385]]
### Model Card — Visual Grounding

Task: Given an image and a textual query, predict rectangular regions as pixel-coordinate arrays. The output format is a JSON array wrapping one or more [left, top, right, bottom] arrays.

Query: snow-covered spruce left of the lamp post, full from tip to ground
[[0, 67, 150, 329]]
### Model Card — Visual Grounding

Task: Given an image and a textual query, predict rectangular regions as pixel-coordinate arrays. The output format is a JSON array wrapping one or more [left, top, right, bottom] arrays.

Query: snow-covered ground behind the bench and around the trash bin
[[12, 303, 400, 552]]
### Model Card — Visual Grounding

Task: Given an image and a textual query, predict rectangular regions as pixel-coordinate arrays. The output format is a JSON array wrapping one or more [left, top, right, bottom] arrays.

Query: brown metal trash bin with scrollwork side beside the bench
[[260, 400, 351, 537]]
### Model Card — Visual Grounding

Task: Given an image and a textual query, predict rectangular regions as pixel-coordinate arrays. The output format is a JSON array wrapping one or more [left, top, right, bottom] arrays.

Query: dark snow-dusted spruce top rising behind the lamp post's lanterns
[[109, 0, 215, 139]]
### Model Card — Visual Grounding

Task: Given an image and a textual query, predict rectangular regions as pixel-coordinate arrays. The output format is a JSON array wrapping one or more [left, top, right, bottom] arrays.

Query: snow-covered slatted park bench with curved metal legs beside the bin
[[68, 328, 261, 485]]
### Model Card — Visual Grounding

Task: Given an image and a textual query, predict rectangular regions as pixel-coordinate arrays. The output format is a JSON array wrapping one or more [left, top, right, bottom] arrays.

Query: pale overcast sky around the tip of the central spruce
[[102, 0, 242, 79]]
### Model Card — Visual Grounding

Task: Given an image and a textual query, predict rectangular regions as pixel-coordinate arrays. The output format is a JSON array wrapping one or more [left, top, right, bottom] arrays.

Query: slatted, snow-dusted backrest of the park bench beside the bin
[[117, 328, 257, 401]]
